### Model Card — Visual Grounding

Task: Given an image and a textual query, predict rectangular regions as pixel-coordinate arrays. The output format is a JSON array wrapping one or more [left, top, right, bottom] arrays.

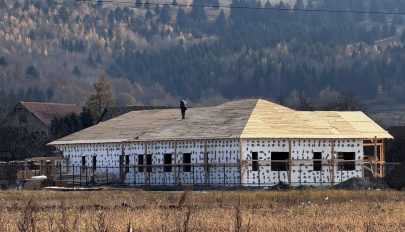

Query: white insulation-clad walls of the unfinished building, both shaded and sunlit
[[58, 139, 363, 186]]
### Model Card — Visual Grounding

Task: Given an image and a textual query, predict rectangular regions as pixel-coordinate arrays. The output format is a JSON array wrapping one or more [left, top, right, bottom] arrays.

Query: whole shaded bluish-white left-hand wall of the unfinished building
[[59, 139, 240, 185]]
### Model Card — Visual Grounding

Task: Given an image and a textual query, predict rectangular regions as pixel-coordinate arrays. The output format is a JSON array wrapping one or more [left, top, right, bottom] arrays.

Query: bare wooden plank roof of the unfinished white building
[[50, 99, 392, 145]]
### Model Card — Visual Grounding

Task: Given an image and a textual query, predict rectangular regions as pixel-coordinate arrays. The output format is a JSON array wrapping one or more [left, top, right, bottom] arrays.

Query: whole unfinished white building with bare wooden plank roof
[[50, 99, 392, 186]]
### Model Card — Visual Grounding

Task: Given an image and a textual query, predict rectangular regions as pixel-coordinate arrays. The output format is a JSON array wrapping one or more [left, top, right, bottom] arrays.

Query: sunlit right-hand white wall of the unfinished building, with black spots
[[242, 139, 363, 186]]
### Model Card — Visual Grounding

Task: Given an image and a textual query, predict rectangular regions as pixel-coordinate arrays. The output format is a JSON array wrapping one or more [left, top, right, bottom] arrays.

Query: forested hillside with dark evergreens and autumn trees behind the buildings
[[0, 0, 405, 121]]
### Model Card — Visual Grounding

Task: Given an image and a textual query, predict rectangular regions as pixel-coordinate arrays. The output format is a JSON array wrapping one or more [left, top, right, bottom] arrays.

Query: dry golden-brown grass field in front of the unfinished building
[[0, 190, 405, 231]]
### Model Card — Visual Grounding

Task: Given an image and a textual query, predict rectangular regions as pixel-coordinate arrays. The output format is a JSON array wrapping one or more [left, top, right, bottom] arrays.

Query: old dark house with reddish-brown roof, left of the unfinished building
[[0, 102, 81, 160]]
